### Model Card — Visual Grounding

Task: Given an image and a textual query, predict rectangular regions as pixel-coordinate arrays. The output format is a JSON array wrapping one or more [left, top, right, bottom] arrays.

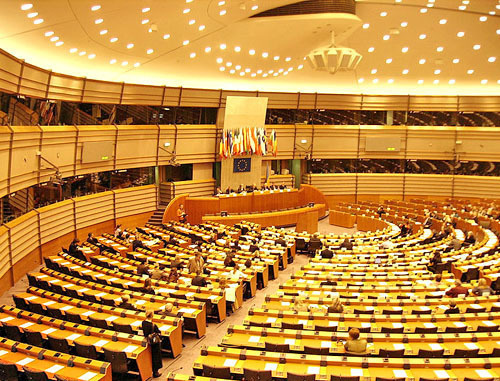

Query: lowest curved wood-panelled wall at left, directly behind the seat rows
[[0, 185, 157, 293]]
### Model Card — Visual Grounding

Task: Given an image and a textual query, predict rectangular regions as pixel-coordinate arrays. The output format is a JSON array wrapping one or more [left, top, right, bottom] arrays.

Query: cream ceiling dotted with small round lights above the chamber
[[0, 0, 500, 95]]
